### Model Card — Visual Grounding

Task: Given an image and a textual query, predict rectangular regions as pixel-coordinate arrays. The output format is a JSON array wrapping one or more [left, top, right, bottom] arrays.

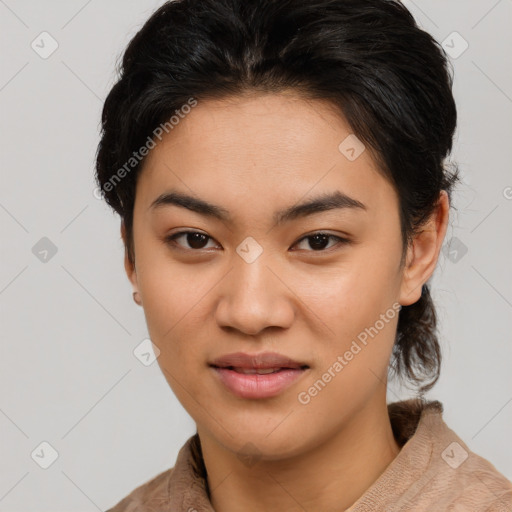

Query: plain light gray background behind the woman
[[0, 0, 512, 512]]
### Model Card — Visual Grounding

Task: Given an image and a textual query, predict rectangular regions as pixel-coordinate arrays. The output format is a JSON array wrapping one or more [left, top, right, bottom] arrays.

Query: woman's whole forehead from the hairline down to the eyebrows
[[137, 92, 396, 219]]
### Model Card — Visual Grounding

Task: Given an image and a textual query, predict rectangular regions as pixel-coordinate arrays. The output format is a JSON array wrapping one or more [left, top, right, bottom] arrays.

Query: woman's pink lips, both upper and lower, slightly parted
[[210, 352, 309, 399]]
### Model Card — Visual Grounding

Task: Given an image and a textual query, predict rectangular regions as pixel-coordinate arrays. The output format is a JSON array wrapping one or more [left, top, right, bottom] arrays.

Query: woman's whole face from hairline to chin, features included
[[126, 94, 421, 459]]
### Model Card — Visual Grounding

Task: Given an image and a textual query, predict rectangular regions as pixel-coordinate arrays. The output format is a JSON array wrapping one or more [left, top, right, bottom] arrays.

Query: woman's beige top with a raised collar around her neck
[[107, 399, 512, 512]]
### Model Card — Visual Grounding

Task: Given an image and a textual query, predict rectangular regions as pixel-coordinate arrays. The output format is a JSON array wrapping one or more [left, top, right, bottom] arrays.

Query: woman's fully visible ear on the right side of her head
[[399, 190, 450, 306]]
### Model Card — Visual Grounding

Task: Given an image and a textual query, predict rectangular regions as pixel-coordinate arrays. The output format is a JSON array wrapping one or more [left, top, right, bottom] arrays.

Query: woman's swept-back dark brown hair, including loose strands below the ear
[[96, 0, 458, 392]]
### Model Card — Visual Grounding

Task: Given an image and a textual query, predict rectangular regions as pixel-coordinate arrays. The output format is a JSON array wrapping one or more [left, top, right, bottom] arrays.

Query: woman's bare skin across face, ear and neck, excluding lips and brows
[[121, 92, 449, 512]]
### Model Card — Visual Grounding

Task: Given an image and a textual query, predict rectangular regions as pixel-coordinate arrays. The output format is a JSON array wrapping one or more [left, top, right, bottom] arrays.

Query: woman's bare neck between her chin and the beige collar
[[199, 397, 400, 512]]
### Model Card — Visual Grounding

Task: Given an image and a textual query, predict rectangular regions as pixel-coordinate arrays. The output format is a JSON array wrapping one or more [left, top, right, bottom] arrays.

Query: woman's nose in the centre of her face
[[216, 254, 296, 336]]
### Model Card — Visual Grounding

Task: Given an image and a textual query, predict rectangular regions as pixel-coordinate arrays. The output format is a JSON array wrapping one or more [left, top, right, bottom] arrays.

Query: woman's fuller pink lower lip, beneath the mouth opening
[[212, 367, 306, 398]]
